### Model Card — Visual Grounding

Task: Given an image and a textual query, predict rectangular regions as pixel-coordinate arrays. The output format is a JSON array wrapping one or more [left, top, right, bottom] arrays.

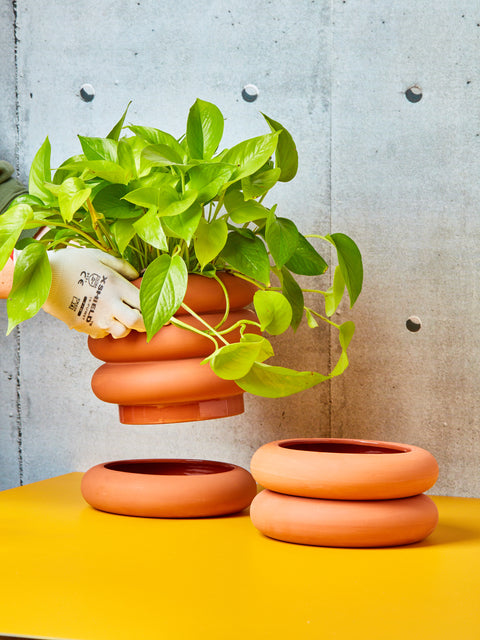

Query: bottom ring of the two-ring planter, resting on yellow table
[[250, 489, 438, 547]]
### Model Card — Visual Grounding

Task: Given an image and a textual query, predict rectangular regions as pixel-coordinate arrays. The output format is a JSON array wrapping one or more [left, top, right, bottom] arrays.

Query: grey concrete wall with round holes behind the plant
[[0, 0, 480, 496]]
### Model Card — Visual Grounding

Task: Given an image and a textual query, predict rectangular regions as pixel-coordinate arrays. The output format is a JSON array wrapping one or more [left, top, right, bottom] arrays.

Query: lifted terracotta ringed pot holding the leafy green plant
[[88, 274, 256, 424]]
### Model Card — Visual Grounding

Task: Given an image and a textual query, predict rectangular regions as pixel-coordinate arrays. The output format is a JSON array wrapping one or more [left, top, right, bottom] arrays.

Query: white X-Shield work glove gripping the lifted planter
[[42, 248, 145, 338]]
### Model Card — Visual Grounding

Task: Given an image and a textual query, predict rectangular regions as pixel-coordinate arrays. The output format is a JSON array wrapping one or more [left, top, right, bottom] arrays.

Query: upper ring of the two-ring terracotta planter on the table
[[250, 438, 438, 500]]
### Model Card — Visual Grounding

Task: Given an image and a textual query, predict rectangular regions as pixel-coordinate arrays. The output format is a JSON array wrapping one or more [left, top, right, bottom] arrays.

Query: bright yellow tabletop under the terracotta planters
[[0, 473, 480, 640]]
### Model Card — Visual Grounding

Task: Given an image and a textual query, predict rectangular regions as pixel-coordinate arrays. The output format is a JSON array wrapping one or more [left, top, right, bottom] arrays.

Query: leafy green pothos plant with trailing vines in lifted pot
[[0, 99, 363, 397]]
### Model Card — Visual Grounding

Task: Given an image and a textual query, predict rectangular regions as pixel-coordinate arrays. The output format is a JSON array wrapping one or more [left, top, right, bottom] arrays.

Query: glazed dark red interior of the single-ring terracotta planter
[[105, 460, 234, 476]]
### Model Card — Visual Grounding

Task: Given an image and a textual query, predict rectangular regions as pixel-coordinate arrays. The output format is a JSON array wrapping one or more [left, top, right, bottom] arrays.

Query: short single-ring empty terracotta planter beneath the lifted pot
[[81, 459, 257, 518]]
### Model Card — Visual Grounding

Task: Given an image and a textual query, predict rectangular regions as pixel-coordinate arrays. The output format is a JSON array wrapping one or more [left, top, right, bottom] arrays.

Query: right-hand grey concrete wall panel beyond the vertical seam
[[332, 1, 480, 495]]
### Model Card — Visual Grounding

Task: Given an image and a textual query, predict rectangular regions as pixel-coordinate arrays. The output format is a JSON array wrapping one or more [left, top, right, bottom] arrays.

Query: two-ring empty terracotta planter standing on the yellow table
[[250, 438, 438, 547]]
